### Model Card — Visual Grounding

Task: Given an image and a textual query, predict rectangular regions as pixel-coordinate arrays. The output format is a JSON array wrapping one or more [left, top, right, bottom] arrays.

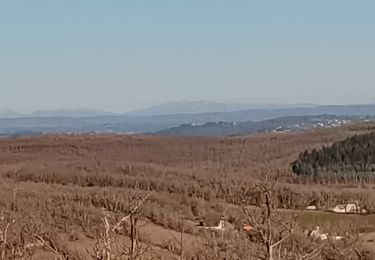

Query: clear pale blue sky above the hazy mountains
[[0, 0, 375, 112]]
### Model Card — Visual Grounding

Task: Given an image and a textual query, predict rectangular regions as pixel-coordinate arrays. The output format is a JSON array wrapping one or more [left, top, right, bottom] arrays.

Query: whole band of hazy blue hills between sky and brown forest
[[0, 102, 375, 136]]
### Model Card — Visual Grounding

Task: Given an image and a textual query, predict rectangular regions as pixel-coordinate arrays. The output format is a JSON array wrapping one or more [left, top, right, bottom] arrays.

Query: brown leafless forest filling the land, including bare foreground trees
[[0, 124, 375, 260]]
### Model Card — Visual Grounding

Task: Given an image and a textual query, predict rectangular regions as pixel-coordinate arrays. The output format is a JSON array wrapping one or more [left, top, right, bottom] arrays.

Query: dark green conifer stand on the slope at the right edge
[[292, 132, 375, 183]]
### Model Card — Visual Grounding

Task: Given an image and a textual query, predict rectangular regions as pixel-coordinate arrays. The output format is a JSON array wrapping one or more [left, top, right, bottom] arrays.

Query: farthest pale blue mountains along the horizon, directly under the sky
[[0, 101, 375, 119]]
